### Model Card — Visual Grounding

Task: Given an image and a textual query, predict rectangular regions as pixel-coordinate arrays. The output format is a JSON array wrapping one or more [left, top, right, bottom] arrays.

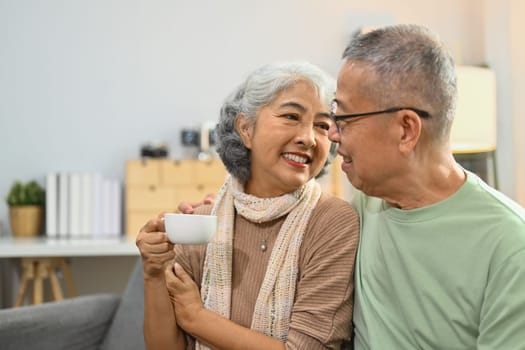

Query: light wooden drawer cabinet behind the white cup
[[126, 159, 226, 239]]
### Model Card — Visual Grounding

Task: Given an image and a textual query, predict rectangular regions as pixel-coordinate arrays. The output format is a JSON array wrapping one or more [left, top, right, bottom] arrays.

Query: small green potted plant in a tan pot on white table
[[6, 181, 45, 236]]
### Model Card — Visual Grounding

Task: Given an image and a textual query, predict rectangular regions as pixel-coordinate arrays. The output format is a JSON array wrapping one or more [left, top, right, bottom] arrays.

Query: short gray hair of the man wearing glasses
[[343, 25, 457, 141]]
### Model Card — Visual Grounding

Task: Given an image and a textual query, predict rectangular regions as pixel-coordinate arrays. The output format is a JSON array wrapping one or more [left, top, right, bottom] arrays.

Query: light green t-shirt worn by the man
[[353, 172, 525, 350]]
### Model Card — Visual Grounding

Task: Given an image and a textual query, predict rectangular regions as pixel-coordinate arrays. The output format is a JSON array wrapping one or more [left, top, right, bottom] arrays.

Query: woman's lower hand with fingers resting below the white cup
[[165, 263, 204, 334]]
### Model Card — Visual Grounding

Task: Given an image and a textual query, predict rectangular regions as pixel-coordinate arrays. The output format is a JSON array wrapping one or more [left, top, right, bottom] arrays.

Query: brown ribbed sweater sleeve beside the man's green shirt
[[286, 197, 359, 350]]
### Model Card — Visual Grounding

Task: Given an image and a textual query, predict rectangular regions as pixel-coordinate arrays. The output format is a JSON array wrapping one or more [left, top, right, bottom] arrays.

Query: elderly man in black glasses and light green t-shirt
[[330, 25, 525, 350]]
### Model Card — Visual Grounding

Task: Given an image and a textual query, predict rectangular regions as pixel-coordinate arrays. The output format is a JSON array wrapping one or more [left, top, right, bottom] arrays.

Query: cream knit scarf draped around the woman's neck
[[196, 176, 321, 350]]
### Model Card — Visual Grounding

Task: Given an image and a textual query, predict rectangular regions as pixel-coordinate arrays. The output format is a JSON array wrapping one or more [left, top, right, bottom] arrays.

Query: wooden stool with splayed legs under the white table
[[14, 257, 77, 307]]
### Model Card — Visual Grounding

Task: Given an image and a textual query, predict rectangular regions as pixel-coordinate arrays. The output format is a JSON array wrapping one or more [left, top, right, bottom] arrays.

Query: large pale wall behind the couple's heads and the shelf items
[[0, 0, 494, 230]]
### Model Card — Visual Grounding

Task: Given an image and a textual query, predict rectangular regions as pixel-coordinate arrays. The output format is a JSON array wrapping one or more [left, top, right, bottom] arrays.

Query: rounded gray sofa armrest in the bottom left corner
[[0, 294, 120, 350]]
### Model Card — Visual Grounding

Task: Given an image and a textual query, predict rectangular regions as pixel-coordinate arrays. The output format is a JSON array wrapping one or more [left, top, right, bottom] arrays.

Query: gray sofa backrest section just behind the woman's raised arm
[[100, 258, 146, 350]]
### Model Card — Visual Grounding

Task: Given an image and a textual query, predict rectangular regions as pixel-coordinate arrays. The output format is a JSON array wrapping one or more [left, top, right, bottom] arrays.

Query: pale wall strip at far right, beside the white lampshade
[[485, 0, 525, 206]]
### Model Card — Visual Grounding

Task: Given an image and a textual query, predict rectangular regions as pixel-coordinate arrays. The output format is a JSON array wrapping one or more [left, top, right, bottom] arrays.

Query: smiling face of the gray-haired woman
[[236, 81, 332, 198]]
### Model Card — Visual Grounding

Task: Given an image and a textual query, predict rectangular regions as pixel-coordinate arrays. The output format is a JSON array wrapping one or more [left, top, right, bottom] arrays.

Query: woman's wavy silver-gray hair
[[215, 62, 337, 183]]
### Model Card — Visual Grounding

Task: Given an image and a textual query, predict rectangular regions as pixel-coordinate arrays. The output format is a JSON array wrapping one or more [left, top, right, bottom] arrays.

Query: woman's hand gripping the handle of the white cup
[[136, 218, 175, 278]]
